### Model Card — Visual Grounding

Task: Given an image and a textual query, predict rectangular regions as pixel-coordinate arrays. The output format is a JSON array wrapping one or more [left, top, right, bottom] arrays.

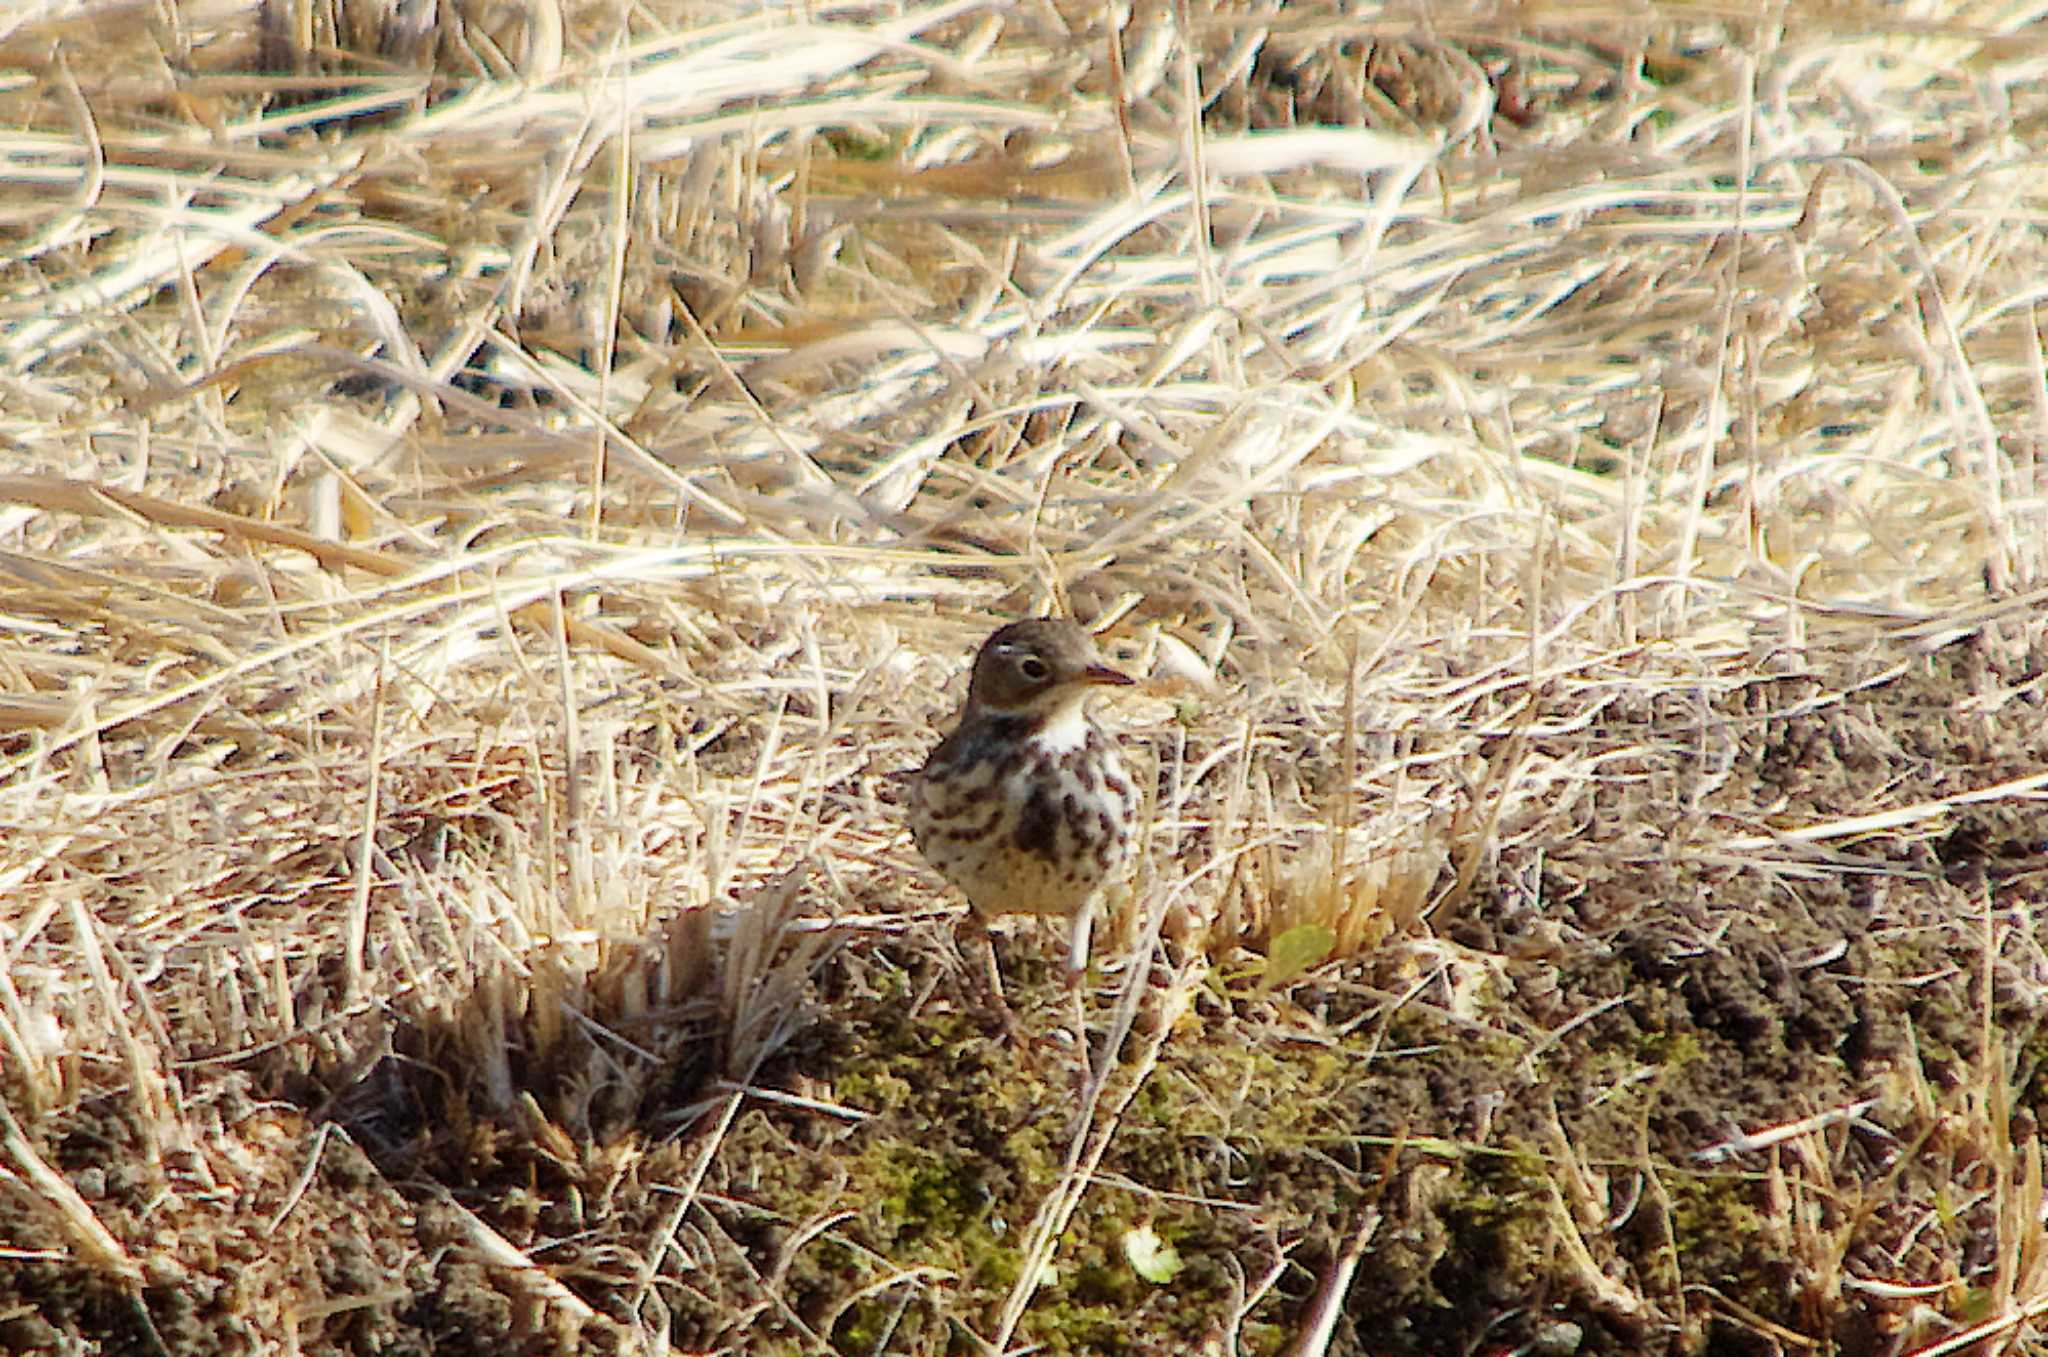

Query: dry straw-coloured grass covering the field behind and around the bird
[[0, 0, 2048, 1353]]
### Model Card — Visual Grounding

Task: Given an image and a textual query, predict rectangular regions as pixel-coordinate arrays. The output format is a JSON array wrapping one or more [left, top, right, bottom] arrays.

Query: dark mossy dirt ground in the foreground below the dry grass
[[0, 620, 2048, 1355]]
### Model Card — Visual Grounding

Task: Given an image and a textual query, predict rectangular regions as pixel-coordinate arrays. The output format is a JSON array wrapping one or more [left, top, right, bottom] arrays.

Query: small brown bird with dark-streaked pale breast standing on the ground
[[909, 618, 1139, 1019]]
